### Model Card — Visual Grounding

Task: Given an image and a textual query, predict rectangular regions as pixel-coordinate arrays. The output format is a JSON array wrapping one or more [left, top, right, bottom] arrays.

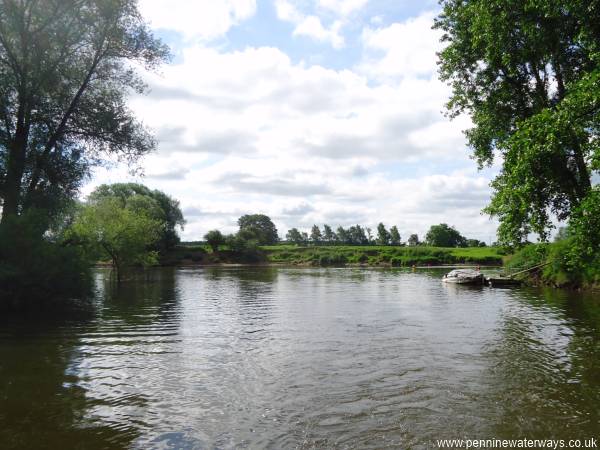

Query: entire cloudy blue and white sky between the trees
[[83, 0, 497, 243]]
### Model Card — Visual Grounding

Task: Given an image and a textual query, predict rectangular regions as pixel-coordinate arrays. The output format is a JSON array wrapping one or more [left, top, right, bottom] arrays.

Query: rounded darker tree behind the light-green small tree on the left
[[88, 183, 185, 250]]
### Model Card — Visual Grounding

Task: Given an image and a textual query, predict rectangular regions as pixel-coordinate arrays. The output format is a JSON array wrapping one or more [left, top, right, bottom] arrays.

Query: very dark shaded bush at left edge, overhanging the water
[[0, 209, 91, 310]]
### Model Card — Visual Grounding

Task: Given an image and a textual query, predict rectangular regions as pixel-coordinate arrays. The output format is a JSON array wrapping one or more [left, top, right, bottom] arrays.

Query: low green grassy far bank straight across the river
[[160, 244, 503, 267]]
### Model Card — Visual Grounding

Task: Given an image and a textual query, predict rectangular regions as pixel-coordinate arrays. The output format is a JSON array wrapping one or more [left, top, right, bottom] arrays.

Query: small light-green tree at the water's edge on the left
[[69, 197, 162, 282]]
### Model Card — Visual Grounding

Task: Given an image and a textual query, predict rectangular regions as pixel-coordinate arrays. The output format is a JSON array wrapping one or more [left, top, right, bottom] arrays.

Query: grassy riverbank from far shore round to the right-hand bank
[[160, 243, 600, 290]]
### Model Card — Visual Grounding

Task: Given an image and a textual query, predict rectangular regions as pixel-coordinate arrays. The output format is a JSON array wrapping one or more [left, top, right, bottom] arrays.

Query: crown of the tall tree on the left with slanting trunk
[[0, 0, 168, 223]]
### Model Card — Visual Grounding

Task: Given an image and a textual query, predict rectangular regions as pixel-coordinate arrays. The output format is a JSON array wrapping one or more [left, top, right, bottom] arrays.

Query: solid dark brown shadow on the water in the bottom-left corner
[[0, 311, 136, 449]]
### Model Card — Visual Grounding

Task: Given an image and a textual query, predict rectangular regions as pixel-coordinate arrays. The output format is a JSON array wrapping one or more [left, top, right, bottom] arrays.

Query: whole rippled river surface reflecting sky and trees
[[0, 268, 600, 449]]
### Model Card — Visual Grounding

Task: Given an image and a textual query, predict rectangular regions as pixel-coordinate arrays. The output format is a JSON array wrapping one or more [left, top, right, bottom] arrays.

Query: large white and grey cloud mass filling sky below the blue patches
[[86, 10, 495, 241]]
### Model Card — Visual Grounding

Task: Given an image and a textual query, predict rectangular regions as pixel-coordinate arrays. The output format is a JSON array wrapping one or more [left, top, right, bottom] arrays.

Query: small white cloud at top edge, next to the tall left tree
[[139, 0, 256, 40]]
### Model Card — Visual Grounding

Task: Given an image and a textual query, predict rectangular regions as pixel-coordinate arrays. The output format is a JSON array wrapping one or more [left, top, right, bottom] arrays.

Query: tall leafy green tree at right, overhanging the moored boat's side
[[435, 0, 600, 244]]
